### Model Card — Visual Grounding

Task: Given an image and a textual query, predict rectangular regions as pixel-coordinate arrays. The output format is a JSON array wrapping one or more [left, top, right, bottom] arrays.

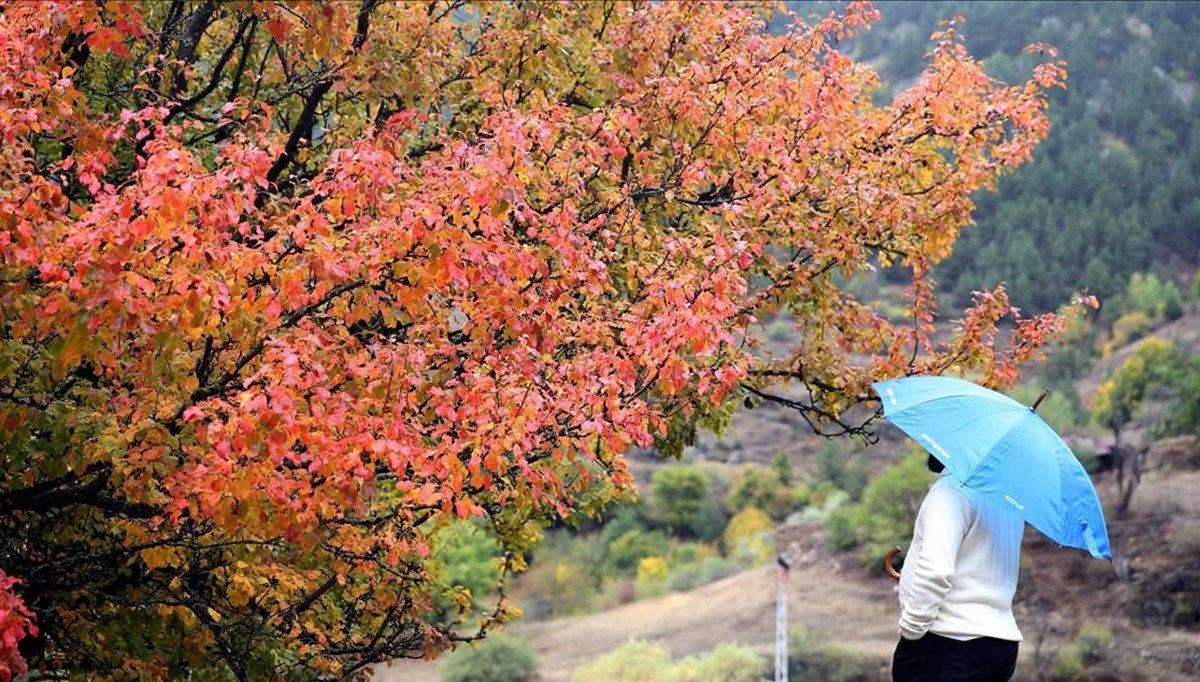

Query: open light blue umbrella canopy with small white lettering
[[872, 377, 1112, 558]]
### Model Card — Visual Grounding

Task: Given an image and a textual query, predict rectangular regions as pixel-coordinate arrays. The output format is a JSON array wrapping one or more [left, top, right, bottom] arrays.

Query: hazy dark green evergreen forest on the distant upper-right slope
[[788, 1, 1200, 311]]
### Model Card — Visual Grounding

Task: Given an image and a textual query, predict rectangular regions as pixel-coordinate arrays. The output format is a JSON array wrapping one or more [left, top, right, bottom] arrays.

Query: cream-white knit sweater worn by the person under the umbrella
[[900, 473, 1025, 641]]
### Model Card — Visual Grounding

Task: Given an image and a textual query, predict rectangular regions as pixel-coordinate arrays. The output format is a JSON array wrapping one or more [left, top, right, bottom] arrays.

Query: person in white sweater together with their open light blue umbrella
[[872, 376, 1112, 682]]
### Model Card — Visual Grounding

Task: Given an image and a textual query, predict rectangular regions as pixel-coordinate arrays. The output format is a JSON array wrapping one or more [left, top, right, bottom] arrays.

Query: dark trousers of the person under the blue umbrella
[[892, 633, 1018, 682]]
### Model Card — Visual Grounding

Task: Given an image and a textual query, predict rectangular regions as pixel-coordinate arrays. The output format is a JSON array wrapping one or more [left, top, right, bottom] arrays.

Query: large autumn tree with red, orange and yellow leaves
[[0, 0, 1084, 680]]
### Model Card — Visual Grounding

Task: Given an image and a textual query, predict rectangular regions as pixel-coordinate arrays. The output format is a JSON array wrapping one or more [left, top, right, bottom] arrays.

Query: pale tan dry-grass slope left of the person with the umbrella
[[377, 563, 896, 682]]
